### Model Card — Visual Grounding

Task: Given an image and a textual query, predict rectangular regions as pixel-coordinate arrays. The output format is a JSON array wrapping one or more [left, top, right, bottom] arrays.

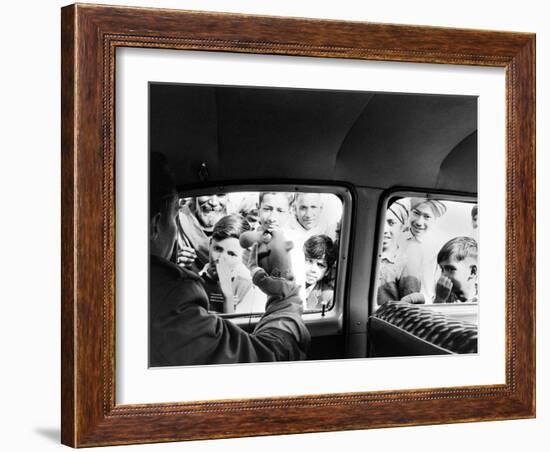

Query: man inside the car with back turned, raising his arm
[[149, 153, 310, 367]]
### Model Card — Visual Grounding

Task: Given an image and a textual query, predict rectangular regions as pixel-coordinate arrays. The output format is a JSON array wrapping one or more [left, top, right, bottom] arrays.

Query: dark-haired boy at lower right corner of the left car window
[[303, 234, 336, 309]]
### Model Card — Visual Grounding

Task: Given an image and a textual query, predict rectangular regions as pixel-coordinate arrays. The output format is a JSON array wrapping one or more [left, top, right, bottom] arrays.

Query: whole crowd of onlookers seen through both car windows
[[172, 188, 484, 314]]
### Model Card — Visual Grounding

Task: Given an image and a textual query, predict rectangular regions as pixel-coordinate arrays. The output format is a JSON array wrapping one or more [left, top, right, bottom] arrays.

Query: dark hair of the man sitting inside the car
[[149, 152, 176, 219]]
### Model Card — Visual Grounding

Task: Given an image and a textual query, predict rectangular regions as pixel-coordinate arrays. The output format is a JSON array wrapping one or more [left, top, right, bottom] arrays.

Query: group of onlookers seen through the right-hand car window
[[376, 198, 478, 305]]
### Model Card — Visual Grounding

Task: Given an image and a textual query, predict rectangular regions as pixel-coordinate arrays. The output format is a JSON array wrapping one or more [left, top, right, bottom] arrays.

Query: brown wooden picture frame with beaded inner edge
[[61, 4, 535, 447]]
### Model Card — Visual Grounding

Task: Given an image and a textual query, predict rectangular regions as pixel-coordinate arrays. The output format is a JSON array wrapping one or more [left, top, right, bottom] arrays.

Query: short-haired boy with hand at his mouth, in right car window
[[434, 237, 478, 303]]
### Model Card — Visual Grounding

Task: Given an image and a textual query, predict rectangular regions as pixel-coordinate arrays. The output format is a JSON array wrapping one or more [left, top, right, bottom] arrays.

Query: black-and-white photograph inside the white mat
[[148, 81, 481, 368]]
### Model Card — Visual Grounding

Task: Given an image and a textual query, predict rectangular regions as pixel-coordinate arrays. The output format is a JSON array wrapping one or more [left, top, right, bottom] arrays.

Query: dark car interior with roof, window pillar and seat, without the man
[[149, 83, 478, 360]]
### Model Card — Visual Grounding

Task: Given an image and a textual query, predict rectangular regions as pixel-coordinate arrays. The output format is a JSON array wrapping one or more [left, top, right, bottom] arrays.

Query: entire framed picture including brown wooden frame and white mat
[[61, 4, 535, 447]]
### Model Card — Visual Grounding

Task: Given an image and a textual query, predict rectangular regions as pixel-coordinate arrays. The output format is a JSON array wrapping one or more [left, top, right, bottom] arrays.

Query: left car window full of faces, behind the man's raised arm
[[177, 191, 344, 316]]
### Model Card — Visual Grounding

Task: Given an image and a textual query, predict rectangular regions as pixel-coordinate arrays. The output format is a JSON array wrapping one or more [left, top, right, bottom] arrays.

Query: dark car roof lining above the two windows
[[149, 83, 477, 193]]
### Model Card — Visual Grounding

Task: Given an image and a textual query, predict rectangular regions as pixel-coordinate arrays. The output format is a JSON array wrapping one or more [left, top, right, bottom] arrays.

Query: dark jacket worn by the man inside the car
[[149, 256, 310, 367]]
